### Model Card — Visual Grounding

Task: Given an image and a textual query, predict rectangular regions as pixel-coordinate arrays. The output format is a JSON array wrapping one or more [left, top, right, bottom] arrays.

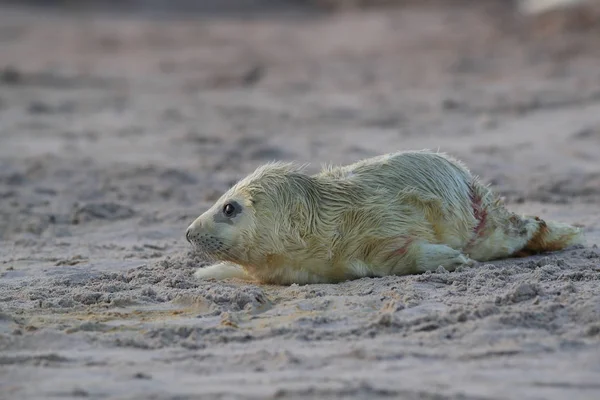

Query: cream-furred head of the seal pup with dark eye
[[186, 162, 316, 269]]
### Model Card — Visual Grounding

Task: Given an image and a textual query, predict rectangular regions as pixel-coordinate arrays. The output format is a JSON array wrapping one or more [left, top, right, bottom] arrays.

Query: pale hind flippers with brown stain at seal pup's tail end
[[519, 217, 584, 256]]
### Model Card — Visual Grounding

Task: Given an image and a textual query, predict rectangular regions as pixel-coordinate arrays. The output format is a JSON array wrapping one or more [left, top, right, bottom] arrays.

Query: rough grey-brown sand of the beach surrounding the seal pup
[[0, 2, 600, 400]]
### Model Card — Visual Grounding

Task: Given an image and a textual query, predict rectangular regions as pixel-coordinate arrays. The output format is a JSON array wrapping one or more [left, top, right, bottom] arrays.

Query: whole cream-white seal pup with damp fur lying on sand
[[186, 151, 581, 284]]
